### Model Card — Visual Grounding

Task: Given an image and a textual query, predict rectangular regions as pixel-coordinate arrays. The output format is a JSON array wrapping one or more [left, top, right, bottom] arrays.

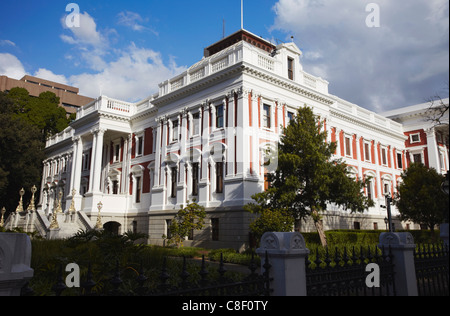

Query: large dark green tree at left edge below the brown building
[[0, 88, 70, 212]]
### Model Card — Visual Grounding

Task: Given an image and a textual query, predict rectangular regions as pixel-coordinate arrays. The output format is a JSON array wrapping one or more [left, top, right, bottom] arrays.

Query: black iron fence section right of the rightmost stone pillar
[[414, 244, 449, 296]]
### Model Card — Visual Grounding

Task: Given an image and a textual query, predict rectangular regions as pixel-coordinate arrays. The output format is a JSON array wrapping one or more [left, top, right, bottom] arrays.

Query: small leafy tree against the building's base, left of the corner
[[163, 202, 206, 247]]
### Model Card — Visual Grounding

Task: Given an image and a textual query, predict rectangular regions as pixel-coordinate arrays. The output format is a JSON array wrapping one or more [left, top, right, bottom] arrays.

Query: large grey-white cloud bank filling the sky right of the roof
[[272, 0, 449, 110]]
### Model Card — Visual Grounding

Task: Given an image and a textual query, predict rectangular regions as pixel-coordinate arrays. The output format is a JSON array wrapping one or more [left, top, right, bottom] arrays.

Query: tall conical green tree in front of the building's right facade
[[247, 107, 373, 246]]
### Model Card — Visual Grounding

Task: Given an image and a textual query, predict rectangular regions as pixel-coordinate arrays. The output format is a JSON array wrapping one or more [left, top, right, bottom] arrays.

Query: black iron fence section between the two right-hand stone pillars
[[306, 247, 396, 296]]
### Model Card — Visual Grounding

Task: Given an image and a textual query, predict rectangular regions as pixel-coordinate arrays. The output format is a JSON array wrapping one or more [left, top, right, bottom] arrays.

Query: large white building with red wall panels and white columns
[[14, 30, 448, 249]]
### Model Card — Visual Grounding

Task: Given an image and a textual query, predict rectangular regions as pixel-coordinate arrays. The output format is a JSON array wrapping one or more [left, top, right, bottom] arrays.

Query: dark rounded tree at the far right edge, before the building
[[394, 163, 449, 230]]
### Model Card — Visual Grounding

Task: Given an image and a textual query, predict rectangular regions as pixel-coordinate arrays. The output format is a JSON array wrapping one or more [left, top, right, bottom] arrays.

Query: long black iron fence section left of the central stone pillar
[[22, 255, 271, 296]]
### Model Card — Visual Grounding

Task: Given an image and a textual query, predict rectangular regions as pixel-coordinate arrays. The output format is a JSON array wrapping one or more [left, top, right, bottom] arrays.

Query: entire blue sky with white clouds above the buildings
[[0, 0, 449, 112]]
